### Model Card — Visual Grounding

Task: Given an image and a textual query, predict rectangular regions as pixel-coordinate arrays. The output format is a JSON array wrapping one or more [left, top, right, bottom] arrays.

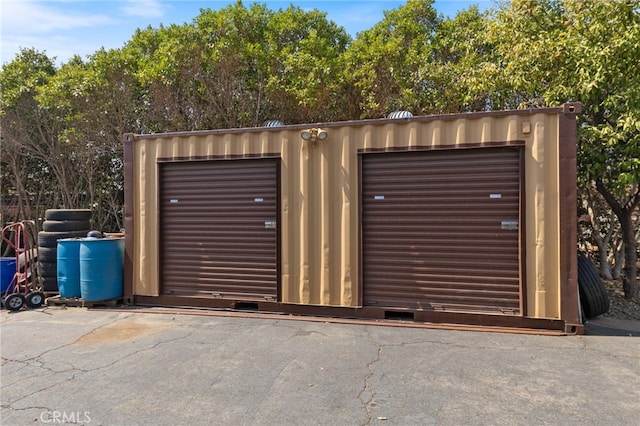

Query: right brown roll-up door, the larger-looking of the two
[[361, 148, 522, 314]]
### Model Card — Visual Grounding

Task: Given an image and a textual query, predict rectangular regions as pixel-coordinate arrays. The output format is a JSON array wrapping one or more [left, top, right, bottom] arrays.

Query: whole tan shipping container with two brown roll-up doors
[[124, 103, 582, 333]]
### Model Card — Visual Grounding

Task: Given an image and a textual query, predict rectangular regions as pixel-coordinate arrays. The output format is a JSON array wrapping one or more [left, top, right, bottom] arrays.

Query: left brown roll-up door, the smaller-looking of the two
[[160, 159, 279, 300]]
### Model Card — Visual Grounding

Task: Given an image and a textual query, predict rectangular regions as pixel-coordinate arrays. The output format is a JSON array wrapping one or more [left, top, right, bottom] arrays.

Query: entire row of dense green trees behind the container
[[0, 0, 640, 297]]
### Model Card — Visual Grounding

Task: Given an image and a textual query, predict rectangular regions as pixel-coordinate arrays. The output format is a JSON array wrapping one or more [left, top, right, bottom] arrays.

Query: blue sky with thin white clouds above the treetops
[[0, 0, 494, 64]]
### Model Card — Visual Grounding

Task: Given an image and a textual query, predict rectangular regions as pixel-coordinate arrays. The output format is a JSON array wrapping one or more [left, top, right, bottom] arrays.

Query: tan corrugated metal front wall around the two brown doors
[[127, 109, 576, 318]]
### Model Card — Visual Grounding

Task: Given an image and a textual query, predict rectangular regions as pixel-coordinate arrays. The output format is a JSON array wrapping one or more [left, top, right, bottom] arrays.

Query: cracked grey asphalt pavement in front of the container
[[0, 307, 640, 426]]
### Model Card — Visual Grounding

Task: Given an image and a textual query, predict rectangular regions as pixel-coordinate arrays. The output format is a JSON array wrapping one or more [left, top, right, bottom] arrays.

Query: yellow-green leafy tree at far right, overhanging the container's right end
[[492, 0, 640, 298]]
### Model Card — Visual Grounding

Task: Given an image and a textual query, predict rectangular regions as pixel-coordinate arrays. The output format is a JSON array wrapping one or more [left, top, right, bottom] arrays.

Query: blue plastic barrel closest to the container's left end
[[80, 238, 124, 302]]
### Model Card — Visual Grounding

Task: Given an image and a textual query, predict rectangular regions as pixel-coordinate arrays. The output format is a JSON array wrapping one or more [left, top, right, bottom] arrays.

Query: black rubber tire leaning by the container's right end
[[578, 253, 609, 319]]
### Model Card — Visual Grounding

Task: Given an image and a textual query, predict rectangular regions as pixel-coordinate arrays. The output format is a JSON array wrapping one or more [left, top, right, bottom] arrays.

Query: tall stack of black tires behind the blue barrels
[[38, 209, 91, 292]]
